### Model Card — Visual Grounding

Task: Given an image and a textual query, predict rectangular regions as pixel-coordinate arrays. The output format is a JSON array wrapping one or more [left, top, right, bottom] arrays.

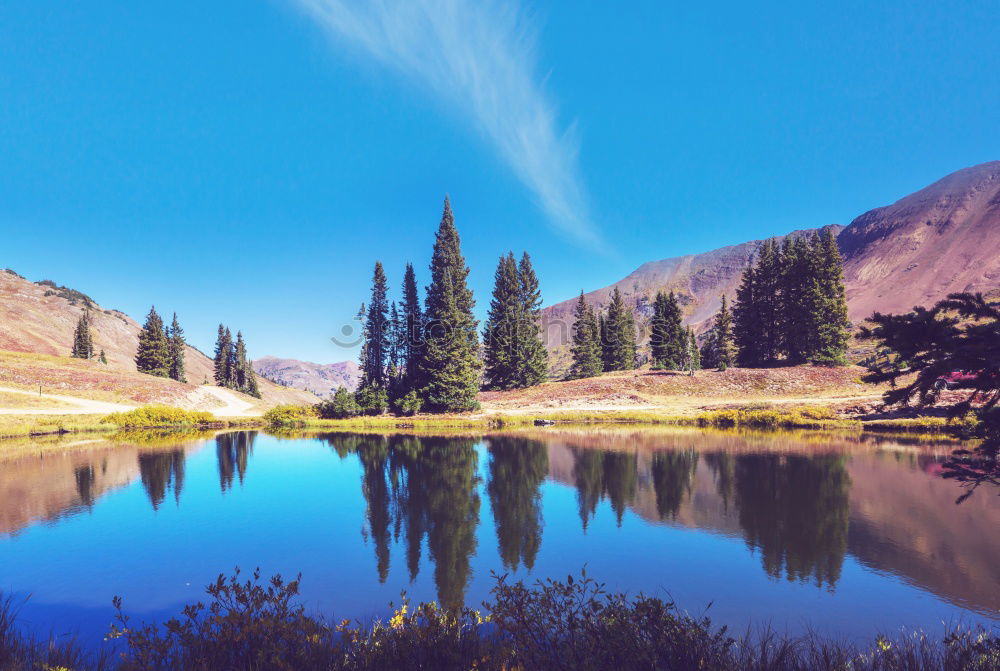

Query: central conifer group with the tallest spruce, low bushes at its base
[[342, 198, 548, 418]]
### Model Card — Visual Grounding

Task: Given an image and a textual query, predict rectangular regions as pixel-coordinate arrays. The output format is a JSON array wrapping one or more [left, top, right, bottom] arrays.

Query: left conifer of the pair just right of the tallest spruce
[[483, 252, 523, 389]]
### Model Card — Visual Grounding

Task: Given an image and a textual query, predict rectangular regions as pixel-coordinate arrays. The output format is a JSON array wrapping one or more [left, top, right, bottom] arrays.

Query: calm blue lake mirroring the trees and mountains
[[0, 429, 1000, 639]]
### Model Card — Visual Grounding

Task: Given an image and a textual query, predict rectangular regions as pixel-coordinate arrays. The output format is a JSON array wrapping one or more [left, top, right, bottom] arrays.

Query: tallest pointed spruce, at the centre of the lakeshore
[[420, 198, 481, 412]]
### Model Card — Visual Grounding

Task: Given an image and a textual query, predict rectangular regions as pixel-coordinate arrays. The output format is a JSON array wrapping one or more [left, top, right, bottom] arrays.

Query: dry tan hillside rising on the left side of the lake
[[0, 270, 317, 409]]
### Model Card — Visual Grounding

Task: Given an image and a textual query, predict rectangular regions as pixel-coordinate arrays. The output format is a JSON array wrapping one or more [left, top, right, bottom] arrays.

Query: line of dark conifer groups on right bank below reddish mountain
[[569, 229, 850, 378]]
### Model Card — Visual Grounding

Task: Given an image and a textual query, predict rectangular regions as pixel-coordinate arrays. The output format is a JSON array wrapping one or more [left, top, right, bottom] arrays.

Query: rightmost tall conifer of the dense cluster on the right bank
[[809, 229, 850, 366]]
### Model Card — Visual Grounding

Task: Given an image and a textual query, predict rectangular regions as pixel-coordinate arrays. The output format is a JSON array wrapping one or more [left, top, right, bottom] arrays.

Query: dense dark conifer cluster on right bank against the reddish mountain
[[733, 229, 850, 367]]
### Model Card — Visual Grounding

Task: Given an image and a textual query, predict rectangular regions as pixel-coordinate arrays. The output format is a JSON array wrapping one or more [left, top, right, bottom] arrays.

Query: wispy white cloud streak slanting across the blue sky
[[293, 0, 603, 248]]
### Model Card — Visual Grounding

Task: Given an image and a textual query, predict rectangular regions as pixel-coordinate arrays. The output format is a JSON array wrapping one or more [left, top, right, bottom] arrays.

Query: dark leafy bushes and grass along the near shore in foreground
[[0, 570, 1000, 671]]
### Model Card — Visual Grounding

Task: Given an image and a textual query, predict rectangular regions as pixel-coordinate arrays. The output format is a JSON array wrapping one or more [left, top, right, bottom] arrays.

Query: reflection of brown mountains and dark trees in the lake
[[0, 430, 1000, 632]]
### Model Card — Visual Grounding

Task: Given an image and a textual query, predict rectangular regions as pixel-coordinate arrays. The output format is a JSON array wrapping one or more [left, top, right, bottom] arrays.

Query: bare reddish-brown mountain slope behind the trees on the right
[[542, 161, 1000, 349]]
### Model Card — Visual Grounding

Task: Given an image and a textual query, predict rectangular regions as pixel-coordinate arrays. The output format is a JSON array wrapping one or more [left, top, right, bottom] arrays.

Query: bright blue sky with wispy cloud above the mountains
[[0, 0, 1000, 362]]
